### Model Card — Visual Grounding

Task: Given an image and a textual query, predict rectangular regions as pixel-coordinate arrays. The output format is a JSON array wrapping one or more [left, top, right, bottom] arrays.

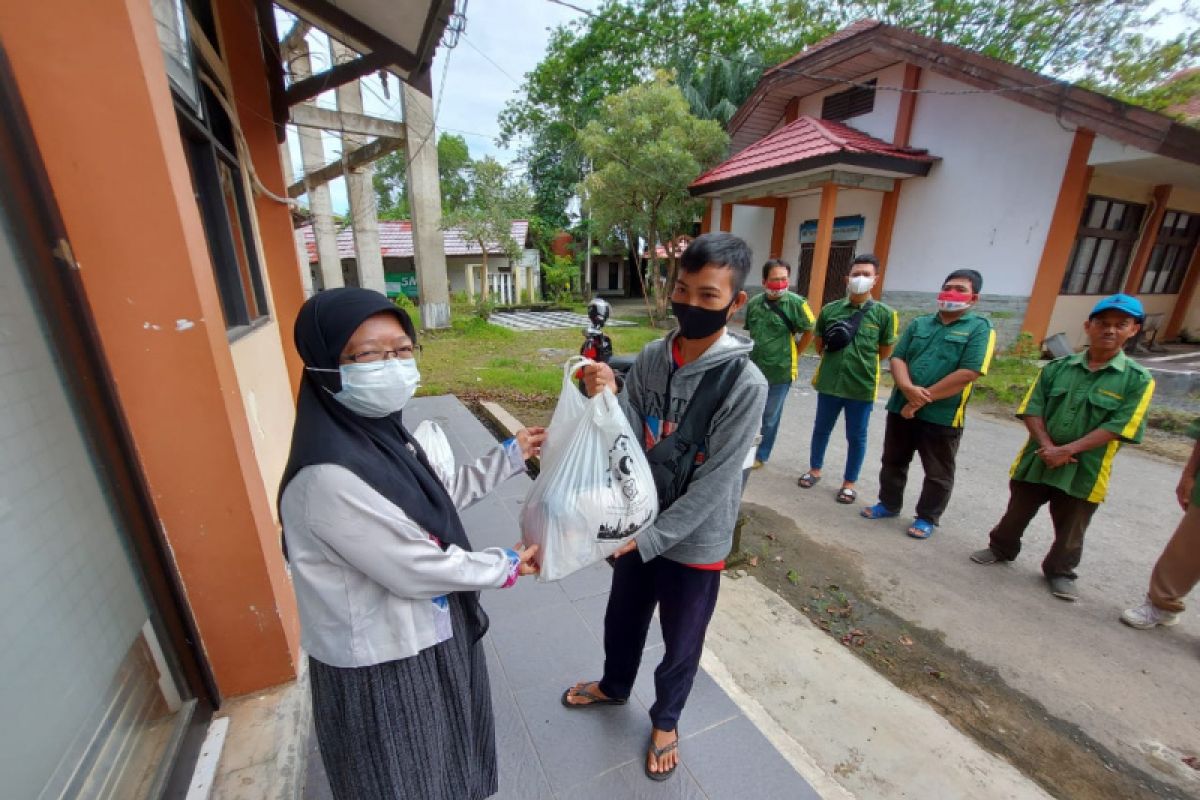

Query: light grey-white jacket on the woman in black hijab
[[280, 440, 524, 667]]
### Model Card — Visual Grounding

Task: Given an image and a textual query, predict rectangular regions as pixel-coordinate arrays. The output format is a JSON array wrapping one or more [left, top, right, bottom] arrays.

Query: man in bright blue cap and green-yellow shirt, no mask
[[971, 294, 1154, 601]]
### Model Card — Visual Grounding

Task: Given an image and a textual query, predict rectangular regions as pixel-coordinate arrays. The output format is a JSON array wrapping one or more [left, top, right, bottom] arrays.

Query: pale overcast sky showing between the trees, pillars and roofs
[[288, 0, 1187, 213]]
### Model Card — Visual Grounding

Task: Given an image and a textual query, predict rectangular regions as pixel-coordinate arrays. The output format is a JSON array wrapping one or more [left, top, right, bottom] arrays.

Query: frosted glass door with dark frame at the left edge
[[0, 52, 209, 800]]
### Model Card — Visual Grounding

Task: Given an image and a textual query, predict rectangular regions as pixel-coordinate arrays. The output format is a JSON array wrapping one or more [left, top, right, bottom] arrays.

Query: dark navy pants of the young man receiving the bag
[[600, 551, 721, 730]]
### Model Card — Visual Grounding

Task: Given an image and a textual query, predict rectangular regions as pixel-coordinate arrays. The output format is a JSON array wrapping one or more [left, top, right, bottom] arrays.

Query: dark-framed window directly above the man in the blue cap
[[1058, 194, 1146, 296]]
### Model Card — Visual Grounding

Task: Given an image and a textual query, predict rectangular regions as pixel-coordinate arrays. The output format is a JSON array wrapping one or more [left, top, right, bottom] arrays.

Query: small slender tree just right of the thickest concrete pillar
[[443, 156, 529, 305]]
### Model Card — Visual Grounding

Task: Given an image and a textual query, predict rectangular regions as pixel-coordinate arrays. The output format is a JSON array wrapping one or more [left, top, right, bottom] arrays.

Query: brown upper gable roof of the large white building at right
[[728, 19, 1200, 164]]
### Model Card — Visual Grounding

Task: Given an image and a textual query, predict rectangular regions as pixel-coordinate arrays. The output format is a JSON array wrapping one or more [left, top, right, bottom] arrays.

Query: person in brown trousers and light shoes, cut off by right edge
[[1121, 420, 1200, 630]]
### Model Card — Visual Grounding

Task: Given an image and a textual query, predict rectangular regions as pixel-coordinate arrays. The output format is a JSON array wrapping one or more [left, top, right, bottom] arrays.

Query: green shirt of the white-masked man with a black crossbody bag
[[812, 297, 900, 403]]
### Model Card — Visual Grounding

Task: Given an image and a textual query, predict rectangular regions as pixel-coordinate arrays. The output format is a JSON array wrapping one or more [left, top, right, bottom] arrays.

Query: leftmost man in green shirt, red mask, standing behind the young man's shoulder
[[746, 258, 814, 469]]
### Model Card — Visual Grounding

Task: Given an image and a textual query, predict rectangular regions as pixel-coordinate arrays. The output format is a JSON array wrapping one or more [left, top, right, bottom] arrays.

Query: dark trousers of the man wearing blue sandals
[[880, 414, 962, 525]]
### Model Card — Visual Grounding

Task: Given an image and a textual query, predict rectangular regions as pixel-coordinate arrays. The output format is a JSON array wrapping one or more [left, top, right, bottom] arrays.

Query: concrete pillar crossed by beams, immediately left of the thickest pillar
[[329, 38, 386, 291]]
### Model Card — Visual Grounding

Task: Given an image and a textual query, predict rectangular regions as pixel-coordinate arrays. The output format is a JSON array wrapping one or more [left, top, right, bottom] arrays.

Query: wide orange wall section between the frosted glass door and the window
[[0, 0, 299, 697]]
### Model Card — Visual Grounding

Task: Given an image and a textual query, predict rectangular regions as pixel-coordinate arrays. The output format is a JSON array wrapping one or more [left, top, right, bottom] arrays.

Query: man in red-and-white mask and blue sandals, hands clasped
[[863, 270, 996, 539]]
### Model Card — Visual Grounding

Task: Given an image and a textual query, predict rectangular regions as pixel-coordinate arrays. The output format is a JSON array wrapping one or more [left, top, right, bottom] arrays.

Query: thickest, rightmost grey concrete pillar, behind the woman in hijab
[[401, 83, 451, 329]]
